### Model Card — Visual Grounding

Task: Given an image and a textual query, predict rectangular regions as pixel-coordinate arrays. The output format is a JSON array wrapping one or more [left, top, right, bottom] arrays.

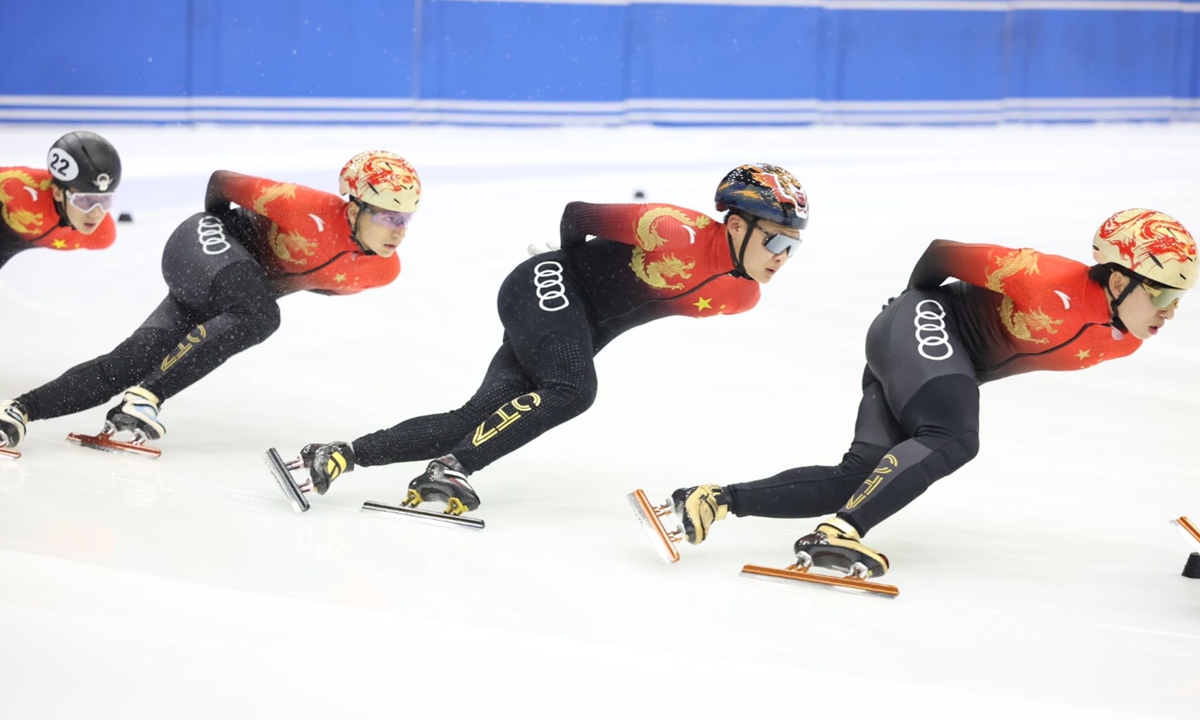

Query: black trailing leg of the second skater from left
[[17, 296, 194, 421]]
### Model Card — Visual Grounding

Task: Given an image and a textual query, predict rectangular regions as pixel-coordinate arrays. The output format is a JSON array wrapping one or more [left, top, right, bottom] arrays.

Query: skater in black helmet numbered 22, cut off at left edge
[[0, 132, 121, 268]]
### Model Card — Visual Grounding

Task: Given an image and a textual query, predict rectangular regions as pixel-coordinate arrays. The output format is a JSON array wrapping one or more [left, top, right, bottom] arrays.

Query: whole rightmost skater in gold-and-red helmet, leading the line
[[672, 209, 1196, 575]]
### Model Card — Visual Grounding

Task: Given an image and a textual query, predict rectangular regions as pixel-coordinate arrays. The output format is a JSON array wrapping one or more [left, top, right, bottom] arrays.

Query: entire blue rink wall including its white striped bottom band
[[0, 0, 1200, 124]]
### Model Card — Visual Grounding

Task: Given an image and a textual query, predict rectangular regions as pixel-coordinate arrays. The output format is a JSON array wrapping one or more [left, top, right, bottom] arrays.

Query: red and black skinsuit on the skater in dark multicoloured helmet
[[353, 203, 758, 472]]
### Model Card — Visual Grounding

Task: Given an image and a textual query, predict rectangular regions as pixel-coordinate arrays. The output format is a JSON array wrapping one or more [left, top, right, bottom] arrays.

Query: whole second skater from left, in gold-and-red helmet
[[0, 151, 421, 446]]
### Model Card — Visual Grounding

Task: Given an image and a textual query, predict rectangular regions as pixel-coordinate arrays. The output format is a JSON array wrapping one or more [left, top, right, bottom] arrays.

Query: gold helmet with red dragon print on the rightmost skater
[[1092, 208, 1196, 290]]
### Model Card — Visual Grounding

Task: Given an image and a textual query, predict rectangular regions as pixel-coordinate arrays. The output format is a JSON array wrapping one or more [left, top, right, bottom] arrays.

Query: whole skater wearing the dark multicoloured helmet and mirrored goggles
[[290, 164, 809, 515]]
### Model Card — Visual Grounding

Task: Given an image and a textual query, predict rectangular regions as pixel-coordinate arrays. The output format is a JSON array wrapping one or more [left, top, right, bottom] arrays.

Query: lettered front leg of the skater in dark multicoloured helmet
[[439, 253, 596, 474]]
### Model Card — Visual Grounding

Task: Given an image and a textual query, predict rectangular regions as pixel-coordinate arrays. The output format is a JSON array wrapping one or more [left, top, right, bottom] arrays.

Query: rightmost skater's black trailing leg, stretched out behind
[[724, 368, 907, 517]]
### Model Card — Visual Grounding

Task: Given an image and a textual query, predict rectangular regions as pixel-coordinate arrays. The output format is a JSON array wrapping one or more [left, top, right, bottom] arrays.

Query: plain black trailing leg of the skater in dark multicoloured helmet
[[352, 341, 533, 467]]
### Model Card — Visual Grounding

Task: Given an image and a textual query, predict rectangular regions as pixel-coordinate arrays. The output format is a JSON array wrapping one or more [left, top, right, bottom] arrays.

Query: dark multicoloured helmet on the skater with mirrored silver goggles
[[715, 163, 809, 230]]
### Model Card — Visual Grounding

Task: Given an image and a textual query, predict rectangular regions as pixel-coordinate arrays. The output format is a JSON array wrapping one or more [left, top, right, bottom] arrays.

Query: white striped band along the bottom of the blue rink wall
[[7, 96, 1200, 126]]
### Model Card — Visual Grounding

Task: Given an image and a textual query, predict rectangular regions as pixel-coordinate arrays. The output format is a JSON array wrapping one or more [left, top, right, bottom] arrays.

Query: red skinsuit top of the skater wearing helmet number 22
[[0, 168, 116, 268]]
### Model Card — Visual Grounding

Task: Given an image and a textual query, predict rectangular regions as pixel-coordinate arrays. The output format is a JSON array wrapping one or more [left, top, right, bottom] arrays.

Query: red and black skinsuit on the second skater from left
[[17, 170, 400, 420]]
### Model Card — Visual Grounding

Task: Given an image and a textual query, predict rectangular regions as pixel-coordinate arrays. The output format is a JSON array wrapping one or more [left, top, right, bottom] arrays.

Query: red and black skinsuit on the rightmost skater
[[725, 240, 1141, 533]]
